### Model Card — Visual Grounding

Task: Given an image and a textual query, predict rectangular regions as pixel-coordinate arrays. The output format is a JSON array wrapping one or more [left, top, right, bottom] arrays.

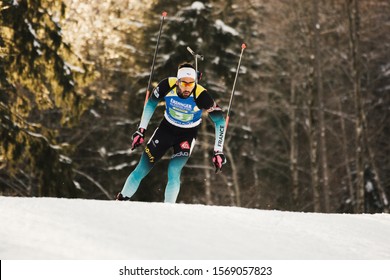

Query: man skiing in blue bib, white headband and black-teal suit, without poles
[[116, 63, 226, 203]]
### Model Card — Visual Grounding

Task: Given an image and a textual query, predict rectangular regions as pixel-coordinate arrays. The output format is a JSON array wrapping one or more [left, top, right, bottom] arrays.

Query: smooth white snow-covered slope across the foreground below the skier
[[0, 196, 390, 260]]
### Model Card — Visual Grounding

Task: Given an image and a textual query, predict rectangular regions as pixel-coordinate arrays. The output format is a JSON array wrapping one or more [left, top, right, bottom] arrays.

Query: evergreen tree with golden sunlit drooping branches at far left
[[0, 0, 88, 197]]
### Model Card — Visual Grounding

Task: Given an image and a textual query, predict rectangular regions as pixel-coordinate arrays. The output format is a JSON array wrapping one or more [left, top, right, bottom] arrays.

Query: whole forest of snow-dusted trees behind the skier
[[0, 0, 390, 213]]
